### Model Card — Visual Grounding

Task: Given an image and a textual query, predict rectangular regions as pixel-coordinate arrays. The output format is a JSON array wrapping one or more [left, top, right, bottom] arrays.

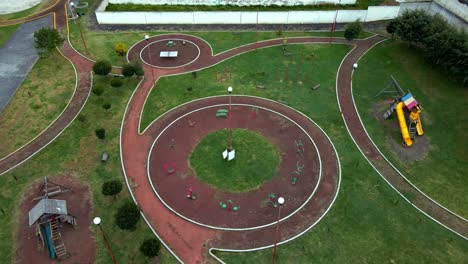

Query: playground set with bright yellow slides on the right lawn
[[376, 76, 424, 147]]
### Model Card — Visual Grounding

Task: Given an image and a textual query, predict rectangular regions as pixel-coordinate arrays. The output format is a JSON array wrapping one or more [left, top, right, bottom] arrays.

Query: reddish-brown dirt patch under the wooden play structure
[[16, 176, 96, 263]]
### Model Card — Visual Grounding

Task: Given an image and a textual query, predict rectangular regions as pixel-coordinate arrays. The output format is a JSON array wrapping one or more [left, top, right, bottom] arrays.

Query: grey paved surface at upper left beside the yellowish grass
[[0, 16, 54, 113]]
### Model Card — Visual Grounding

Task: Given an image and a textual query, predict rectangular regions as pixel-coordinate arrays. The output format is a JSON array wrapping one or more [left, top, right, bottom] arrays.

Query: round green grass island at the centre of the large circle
[[190, 129, 280, 192]]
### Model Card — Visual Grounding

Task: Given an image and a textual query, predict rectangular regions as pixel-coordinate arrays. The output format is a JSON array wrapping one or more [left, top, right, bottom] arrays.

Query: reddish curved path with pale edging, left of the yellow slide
[[336, 37, 468, 239]]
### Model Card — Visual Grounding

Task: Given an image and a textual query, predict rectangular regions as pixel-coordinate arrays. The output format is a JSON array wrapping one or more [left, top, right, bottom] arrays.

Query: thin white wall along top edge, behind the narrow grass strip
[[109, 0, 356, 6]]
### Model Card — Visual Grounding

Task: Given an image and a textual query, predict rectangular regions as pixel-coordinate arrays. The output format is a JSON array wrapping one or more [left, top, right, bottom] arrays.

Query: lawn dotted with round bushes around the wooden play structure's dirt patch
[[0, 76, 175, 263]]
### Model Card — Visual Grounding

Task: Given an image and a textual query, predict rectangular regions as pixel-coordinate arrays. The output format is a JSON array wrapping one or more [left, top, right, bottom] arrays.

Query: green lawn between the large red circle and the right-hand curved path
[[144, 45, 468, 263]]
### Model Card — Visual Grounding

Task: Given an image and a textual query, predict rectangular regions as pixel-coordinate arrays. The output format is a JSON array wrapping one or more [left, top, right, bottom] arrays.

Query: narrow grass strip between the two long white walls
[[106, 0, 384, 12]]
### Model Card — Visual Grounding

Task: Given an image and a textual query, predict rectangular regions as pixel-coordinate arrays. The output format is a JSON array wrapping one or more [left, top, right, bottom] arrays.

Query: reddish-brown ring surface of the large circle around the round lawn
[[149, 96, 334, 229]]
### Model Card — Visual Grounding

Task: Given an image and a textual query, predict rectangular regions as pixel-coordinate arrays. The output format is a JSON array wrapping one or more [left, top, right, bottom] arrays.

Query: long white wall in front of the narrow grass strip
[[96, 5, 400, 24]]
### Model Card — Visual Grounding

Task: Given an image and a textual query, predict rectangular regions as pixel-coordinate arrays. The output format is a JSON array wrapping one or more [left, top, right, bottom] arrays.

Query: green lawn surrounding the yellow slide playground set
[[353, 41, 468, 218]]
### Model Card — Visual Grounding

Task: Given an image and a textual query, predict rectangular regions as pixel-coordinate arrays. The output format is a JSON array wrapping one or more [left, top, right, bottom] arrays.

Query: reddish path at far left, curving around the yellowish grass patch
[[0, 0, 93, 175]]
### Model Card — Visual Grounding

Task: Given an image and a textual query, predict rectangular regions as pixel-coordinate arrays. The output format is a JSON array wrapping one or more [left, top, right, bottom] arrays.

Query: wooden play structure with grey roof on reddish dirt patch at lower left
[[29, 177, 77, 259]]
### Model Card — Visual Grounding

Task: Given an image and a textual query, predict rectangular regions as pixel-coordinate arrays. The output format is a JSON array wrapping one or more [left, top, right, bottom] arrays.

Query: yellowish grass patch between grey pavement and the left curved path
[[0, 50, 76, 157]]
